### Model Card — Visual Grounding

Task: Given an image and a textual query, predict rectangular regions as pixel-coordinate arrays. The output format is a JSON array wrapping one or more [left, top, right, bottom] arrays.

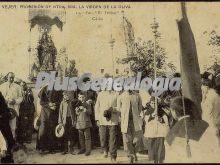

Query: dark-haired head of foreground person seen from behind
[[170, 96, 196, 120]]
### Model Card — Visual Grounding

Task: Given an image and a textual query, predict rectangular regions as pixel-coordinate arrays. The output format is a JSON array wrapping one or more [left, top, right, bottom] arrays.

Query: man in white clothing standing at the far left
[[0, 72, 23, 138]]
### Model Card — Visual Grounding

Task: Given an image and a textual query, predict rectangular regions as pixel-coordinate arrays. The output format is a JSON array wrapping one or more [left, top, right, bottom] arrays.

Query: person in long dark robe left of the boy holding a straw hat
[[37, 86, 63, 153]]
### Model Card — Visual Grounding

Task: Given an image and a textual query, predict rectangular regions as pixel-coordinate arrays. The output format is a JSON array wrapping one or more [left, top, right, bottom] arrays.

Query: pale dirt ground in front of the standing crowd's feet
[[25, 134, 150, 164]]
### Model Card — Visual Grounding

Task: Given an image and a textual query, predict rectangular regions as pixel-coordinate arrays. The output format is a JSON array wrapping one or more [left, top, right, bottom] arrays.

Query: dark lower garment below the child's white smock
[[147, 137, 165, 163]]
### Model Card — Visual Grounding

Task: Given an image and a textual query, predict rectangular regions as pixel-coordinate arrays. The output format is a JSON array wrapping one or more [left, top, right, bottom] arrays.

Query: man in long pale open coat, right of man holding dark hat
[[117, 91, 143, 163]]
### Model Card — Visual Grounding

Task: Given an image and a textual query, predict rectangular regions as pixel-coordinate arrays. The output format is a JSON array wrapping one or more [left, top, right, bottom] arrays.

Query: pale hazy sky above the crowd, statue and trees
[[0, 2, 220, 80]]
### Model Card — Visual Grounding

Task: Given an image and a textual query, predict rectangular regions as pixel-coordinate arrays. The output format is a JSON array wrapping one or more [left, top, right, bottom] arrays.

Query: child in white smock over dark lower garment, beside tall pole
[[144, 97, 169, 163]]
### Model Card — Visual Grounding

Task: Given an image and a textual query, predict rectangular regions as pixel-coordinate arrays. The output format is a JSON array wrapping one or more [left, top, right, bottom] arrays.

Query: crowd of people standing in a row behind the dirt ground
[[0, 72, 220, 163]]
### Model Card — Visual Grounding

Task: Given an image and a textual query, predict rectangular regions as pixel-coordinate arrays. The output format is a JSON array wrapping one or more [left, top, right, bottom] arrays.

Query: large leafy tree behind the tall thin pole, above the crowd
[[117, 37, 176, 78]]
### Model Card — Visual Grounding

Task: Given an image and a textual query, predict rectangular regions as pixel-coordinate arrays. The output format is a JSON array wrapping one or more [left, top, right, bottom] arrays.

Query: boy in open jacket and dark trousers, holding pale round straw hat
[[58, 91, 77, 155]]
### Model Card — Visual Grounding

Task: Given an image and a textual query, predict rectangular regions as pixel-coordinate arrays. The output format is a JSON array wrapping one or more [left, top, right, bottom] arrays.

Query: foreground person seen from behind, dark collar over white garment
[[165, 96, 208, 163]]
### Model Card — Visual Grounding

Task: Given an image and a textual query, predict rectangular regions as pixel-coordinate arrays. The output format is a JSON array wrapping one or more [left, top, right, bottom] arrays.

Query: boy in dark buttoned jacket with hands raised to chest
[[75, 92, 92, 156]]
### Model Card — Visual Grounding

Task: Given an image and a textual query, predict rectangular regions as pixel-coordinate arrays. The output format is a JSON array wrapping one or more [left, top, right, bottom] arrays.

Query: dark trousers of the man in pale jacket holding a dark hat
[[99, 125, 118, 159]]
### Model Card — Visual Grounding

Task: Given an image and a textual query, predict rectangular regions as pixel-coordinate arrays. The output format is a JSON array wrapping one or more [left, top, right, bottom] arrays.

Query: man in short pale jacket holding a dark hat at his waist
[[95, 91, 119, 162]]
